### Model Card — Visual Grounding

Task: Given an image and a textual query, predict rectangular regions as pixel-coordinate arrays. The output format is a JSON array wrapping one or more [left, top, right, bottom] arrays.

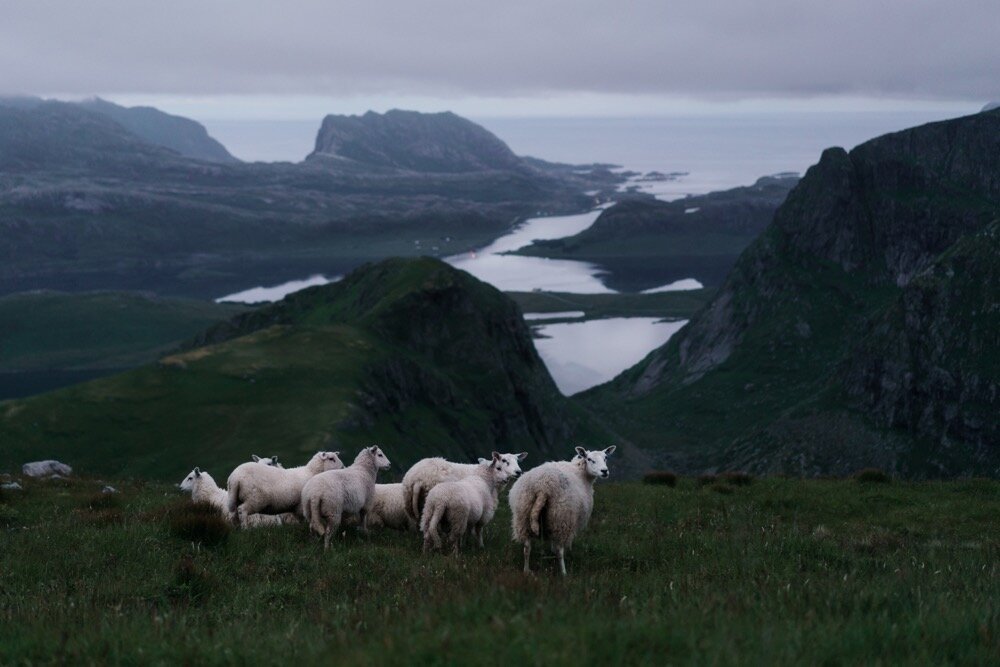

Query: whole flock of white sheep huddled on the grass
[[178, 445, 615, 575]]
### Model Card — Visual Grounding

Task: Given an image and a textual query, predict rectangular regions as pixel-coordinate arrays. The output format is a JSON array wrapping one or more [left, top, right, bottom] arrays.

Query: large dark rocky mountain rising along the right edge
[[585, 112, 1000, 476]]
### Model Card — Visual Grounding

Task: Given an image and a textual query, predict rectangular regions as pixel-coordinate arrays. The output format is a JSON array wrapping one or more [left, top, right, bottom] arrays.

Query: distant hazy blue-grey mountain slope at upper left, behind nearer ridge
[[78, 97, 239, 163]]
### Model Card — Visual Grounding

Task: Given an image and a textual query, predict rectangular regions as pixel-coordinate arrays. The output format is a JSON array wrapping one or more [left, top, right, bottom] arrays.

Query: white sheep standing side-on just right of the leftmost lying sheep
[[226, 452, 344, 525]]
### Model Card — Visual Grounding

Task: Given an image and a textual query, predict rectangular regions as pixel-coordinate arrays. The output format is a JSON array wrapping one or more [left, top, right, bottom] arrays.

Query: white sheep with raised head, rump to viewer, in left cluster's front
[[300, 447, 390, 550]]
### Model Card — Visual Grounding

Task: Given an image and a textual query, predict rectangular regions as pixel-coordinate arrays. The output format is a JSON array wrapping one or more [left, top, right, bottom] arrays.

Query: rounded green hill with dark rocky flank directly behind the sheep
[[0, 258, 605, 480]]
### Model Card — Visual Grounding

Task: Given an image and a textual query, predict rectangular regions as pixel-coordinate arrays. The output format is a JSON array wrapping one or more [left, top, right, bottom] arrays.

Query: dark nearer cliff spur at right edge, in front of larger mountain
[[842, 222, 1000, 460]]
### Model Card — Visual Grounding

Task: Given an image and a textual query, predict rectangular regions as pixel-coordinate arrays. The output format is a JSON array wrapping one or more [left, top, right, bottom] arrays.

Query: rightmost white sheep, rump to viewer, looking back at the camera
[[508, 445, 615, 576]]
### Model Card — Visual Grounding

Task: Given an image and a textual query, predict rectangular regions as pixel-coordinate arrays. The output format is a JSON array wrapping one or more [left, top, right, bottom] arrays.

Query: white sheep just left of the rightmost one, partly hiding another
[[420, 452, 512, 554]]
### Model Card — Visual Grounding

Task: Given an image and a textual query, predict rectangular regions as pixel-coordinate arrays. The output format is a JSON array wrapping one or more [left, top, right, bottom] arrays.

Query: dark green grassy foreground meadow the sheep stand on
[[0, 478, 1000, 665]]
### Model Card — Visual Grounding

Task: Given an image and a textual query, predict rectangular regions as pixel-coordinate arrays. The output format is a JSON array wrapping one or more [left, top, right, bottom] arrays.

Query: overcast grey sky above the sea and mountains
[[0, 0, 1000, 117]]
